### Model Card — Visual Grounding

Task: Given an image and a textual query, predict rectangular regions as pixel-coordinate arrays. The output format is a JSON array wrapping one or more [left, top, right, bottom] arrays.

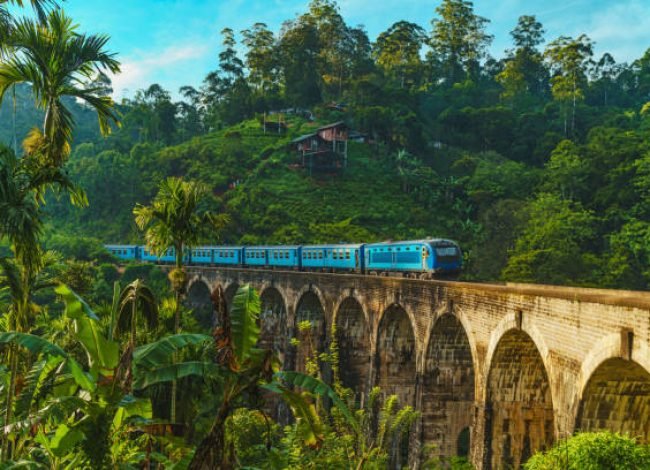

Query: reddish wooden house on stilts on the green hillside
[[291, 121, 349, 173]]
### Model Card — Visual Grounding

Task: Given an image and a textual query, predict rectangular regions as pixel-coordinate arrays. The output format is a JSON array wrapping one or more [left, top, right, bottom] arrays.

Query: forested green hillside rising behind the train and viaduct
[[0, 0, 650, 289]]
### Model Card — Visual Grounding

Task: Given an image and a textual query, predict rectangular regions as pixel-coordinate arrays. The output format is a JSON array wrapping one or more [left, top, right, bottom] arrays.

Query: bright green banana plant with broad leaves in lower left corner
[[0, 285, 152, 468]]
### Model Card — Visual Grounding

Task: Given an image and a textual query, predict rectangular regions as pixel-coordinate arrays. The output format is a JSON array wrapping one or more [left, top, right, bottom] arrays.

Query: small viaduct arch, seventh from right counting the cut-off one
[[258, 286, 289, 365]]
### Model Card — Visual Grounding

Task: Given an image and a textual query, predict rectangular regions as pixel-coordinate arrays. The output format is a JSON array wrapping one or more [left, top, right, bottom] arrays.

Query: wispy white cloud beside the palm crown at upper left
[[111, 43, 209, 98]]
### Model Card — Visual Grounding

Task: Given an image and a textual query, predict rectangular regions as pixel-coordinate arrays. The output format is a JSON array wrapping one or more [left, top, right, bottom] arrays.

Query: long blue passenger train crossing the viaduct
[[106, 239, 463, 278]]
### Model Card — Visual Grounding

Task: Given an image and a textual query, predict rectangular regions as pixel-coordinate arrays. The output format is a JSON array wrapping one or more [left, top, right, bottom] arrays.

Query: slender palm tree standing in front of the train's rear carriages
[[133, 178, 228, 422]]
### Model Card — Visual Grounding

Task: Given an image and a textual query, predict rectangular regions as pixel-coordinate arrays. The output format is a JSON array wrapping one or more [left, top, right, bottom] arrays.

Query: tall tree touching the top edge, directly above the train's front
[[430, 0, 492, 85]]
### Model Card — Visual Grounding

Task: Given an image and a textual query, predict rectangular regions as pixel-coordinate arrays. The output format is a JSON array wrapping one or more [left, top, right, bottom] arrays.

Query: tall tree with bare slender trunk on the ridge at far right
[[544, 34, 593, 137]]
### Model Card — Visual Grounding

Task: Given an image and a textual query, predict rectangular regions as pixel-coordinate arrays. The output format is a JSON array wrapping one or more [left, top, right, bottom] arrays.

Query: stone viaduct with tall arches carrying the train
[[182, 268, 650, 469]]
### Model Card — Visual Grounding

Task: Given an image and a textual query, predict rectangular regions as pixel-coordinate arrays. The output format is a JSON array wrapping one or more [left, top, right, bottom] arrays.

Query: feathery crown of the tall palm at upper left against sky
[[0, 7, 120, 166]]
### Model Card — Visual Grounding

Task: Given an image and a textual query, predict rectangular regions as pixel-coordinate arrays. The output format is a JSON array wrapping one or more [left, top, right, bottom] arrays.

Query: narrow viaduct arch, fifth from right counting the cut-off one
[[333, 296, 371, 402]]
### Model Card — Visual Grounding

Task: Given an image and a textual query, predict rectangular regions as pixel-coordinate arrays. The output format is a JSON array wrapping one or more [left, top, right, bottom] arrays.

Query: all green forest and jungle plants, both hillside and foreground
[[0, 0, 650, 470]]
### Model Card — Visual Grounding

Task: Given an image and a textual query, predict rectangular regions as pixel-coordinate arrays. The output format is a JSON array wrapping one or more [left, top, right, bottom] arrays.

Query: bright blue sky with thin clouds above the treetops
[[19, 0, 650, 98]]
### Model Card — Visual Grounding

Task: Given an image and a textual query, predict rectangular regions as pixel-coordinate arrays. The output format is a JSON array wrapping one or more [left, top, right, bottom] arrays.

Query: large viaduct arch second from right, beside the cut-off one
[[485, 328, 555, 468]]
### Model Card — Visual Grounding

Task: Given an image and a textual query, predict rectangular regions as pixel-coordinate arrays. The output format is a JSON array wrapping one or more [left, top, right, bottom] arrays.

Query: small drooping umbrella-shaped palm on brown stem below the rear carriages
[[111, 279, 158, 391]]
